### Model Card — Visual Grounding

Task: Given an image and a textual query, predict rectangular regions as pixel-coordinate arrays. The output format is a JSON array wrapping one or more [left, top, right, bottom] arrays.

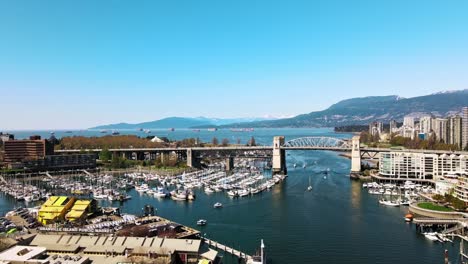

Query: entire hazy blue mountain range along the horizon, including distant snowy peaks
[[93, 89, 468, 129]]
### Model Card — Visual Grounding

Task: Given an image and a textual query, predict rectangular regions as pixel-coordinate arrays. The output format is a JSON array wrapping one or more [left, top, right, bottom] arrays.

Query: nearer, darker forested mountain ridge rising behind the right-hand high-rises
[[223, 89, 468, 127]]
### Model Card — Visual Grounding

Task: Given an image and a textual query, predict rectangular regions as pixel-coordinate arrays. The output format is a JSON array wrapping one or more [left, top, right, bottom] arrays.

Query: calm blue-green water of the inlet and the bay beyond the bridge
[[0, 129, 459, 264]]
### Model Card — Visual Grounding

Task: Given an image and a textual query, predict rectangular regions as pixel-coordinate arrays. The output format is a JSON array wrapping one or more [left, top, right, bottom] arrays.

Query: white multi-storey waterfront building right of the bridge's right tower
[[379, 152, 468, 180]]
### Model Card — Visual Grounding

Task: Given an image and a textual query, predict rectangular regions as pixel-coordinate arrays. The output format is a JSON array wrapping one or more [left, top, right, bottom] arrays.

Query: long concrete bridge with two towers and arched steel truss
[[56, 136, 466, 174]]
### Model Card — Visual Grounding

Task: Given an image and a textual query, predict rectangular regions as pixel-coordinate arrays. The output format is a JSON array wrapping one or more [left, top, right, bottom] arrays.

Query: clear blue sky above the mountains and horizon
[[0, 0, 468, 130]]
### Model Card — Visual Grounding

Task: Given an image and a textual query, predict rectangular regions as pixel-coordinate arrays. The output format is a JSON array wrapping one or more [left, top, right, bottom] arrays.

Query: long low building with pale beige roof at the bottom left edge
[[30, 234, 219, 263]]
